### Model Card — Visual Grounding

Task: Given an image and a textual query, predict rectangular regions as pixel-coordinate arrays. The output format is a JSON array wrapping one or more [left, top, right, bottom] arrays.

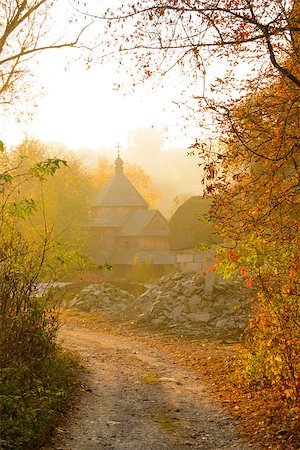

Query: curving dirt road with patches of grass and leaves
[[45, 326, 258, 450]]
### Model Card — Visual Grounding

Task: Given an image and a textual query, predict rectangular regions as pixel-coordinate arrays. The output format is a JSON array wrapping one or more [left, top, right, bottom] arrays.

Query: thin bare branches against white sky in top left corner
[[0, 0, 88, 115]]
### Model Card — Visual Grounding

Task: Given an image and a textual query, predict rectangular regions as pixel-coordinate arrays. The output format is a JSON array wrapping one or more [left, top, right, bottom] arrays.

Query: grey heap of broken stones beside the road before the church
[[68, 272, 249, 338]]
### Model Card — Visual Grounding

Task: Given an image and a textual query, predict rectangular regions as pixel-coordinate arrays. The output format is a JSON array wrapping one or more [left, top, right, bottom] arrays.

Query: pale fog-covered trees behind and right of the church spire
[[76, 127, 202, 219]]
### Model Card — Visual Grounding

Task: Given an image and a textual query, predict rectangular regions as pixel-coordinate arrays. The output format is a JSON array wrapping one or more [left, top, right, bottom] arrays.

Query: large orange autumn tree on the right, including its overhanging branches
[[76, 0, 300, 432]]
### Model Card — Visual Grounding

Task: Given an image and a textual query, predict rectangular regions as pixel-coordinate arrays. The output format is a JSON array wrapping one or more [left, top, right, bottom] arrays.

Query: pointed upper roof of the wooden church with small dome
[[92, 156, 148, 209]]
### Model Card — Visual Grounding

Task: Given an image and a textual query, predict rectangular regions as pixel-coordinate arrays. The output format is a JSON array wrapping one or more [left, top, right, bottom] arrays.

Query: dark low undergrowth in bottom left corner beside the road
[[0, 350, 79, 450]]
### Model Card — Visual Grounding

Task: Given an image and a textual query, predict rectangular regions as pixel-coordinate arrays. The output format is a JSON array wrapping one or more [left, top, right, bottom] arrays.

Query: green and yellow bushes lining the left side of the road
[[0, 147, 85, 449]]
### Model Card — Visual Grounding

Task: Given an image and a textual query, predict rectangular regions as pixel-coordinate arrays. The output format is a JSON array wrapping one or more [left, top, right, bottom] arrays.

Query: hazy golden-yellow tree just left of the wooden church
[[11, 139, 94, 254]]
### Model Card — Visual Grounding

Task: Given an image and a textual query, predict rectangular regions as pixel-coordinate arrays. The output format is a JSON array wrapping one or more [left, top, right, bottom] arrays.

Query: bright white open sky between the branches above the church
[[2, 46, 199, 150]]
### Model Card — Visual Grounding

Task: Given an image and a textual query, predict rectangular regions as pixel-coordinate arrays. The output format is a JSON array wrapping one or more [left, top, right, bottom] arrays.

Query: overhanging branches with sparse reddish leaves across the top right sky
[[78, 0, 300, 134]]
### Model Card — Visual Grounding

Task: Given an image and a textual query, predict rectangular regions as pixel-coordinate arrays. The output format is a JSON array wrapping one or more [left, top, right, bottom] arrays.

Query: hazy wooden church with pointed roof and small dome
[[88, 154, 174, 266]]
